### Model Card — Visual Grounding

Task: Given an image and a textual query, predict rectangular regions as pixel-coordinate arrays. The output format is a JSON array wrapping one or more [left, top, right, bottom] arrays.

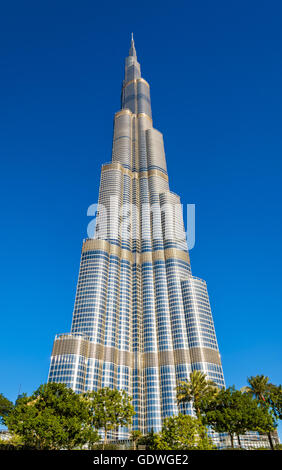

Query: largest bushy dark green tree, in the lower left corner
[[5, 383, 99, 450]]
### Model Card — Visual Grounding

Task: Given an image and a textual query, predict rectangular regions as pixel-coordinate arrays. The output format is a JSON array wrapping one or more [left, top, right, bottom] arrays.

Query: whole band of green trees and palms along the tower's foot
[[0, 371, 282, 450]]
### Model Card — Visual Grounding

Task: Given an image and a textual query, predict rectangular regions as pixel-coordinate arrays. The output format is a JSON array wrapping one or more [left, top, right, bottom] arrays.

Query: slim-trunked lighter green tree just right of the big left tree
[[84, 387, 135, 449]]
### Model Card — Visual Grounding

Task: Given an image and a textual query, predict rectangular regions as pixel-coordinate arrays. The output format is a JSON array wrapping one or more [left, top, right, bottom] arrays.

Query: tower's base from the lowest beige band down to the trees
[[48, 333, 223, 439]]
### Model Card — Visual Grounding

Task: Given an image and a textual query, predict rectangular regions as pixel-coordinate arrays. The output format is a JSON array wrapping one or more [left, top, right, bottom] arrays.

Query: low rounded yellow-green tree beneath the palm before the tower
[[156, 414, 214, 450]]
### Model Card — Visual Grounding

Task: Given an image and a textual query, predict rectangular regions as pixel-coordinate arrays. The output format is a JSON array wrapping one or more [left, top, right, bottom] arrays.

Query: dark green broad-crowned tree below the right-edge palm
[[201, 387, 274, 448]]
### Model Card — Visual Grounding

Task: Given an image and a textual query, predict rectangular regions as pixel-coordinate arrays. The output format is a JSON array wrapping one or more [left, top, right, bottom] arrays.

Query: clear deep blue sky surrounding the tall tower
[[0, 0, 282, 436]]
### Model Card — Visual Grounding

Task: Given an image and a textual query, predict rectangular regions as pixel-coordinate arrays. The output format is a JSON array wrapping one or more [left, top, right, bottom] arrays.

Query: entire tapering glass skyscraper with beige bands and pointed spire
[[48, 37, 224, 438]]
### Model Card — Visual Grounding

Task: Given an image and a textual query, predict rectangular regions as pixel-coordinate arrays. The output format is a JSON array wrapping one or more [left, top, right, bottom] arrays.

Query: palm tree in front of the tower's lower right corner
[[176, 370, 219, 419]]
